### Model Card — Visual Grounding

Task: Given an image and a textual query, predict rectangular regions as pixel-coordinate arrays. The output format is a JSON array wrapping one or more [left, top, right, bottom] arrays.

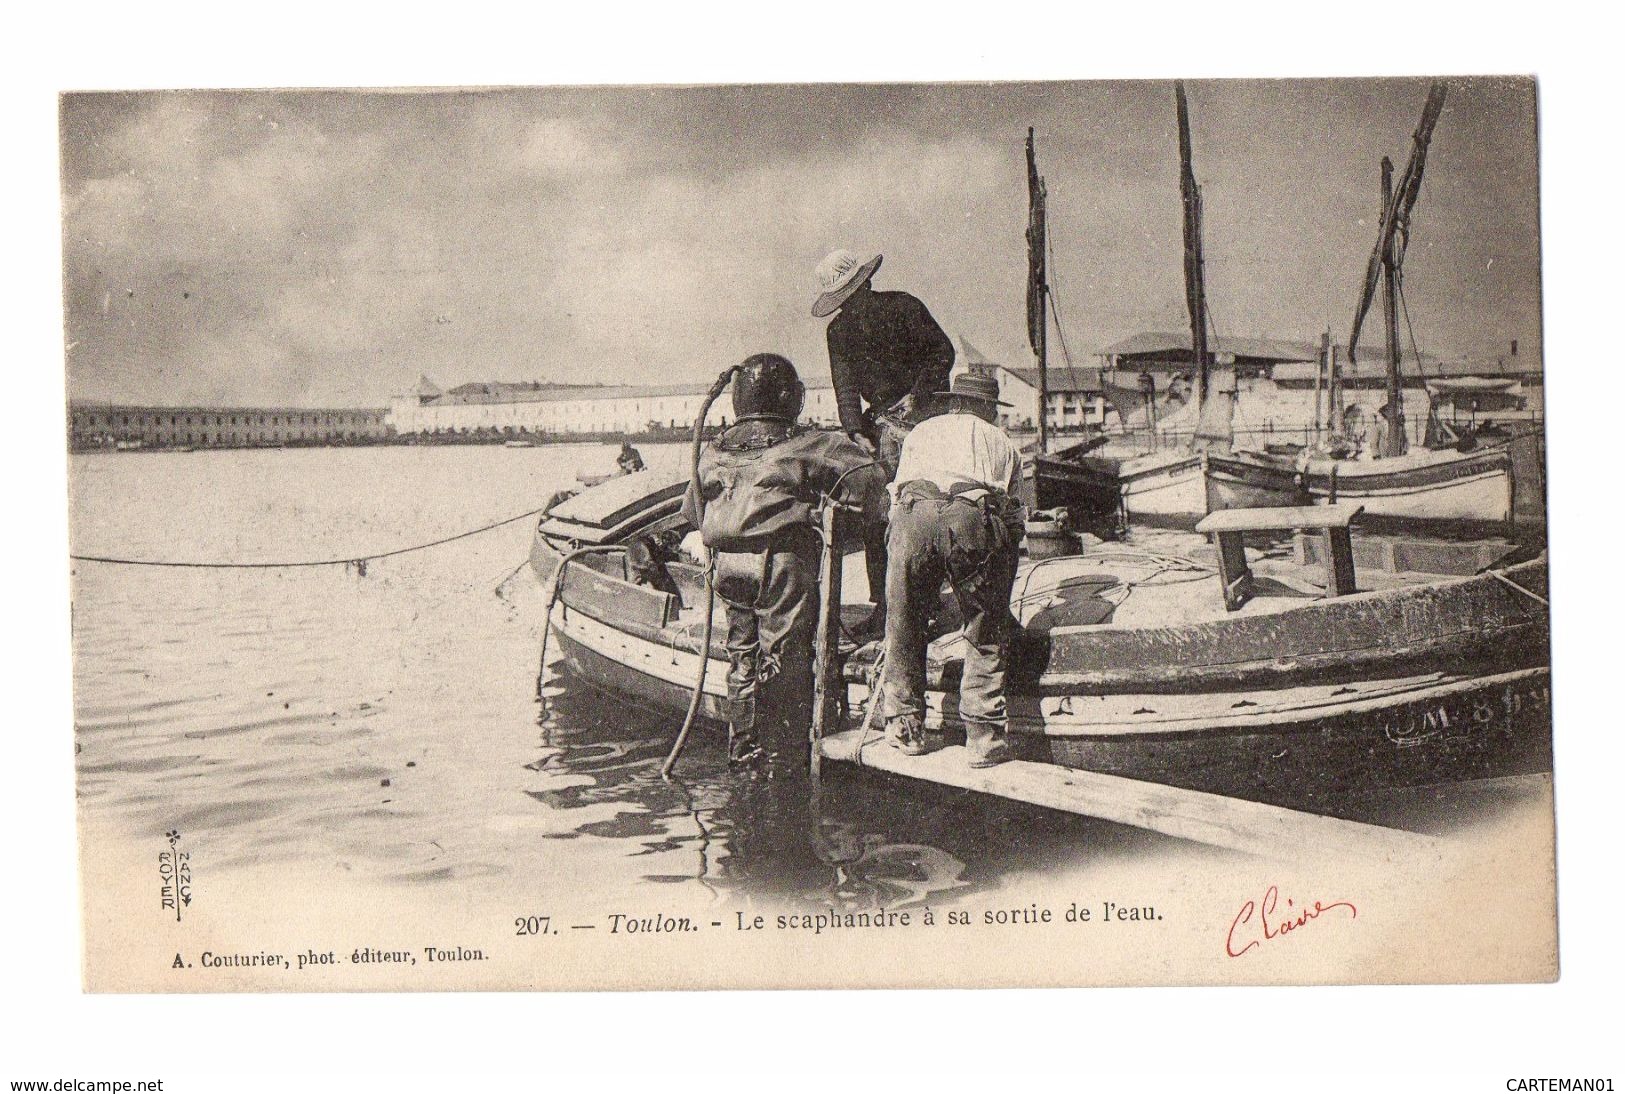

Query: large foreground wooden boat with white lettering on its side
[[530, 455, 1550, 798]]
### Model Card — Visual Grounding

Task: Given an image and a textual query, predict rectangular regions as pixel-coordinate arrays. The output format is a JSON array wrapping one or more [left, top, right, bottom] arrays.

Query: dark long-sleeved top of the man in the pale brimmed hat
[[824, 293, 954, 432]]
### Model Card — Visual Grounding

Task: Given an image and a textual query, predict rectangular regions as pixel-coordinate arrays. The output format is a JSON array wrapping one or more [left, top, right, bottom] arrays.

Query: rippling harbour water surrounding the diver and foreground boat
[[72, 445, 1217, 907]]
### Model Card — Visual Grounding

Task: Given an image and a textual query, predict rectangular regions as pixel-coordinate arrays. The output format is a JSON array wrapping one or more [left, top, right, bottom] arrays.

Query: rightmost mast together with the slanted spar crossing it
[[1349, 83, 1445, 455]]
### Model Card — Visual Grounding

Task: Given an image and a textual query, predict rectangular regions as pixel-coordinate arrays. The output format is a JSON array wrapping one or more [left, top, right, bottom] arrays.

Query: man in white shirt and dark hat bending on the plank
[[881, 374, 1022, 767]]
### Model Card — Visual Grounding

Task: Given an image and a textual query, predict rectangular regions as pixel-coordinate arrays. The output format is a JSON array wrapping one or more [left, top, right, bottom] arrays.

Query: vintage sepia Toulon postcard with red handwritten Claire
[[60, 76, 1558, 992]]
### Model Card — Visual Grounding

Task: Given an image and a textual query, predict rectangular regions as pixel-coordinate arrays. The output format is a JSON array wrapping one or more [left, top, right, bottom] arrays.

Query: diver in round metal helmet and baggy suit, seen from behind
[[683, 353, 886, 766]]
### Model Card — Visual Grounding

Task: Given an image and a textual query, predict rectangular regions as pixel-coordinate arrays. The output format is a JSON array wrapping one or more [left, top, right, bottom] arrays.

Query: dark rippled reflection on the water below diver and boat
[[530, 671, 1176, 912]]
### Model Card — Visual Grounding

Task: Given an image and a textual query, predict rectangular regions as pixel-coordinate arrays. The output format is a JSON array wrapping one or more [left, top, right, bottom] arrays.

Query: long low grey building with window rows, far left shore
[[68, 400, 390, 452]]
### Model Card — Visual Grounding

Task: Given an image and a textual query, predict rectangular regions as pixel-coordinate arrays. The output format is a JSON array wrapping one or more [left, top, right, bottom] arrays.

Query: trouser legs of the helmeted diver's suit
[[715, 528, 821, 759]]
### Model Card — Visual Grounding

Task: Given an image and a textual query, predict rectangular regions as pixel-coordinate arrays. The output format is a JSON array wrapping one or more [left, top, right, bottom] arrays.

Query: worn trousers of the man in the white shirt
[[881, 483, 1019, 732]]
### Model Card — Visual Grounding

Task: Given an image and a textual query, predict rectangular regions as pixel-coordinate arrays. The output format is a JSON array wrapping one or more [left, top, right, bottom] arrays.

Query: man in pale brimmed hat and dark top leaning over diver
[[813, 250, 954, 634]]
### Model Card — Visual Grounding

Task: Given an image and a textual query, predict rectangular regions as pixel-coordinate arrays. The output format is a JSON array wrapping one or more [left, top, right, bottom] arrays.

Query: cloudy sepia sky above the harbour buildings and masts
[[60, 78, 1541, 406]]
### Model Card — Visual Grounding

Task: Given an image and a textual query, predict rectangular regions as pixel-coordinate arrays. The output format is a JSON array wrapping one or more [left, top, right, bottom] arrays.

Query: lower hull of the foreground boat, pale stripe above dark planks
[[554, 588, 1550, 803]]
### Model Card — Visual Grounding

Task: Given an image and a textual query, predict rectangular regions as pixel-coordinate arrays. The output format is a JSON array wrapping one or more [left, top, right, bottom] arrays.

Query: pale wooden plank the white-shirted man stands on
[[817, 730, 1443, 862]]
